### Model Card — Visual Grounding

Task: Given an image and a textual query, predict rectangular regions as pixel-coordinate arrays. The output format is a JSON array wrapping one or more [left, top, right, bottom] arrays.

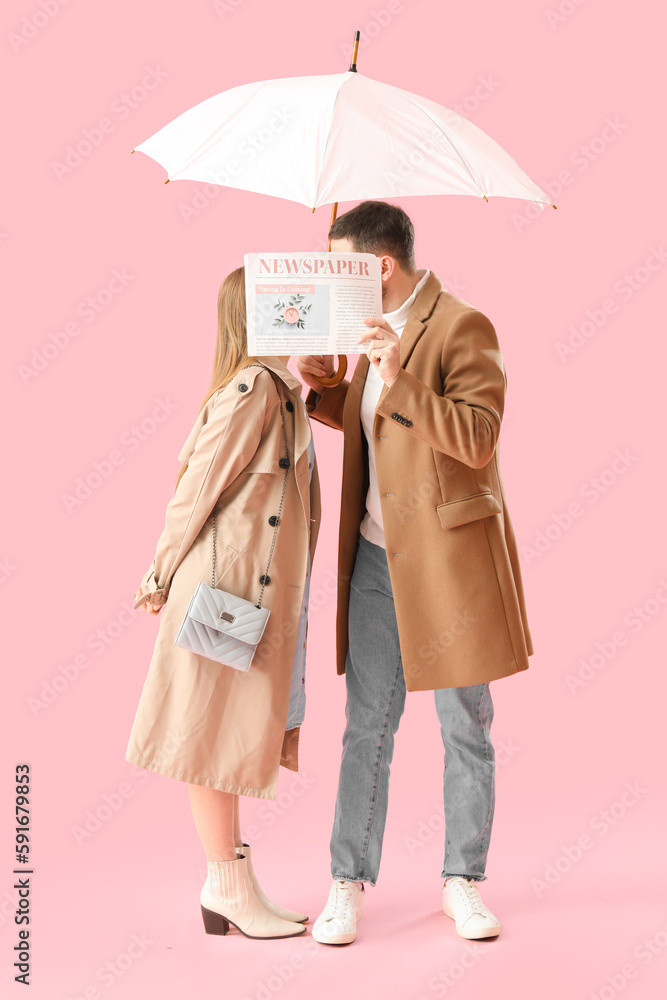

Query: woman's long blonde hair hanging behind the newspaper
[[174, 267, 257, 491]]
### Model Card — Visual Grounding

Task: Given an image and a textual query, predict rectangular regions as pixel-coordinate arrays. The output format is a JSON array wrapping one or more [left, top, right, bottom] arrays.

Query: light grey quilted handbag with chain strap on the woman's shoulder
[[174, 369, 290, 671]]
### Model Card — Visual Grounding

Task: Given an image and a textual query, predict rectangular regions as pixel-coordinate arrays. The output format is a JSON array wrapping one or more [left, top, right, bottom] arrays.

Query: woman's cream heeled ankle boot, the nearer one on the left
[[200, 854, 306, 938]]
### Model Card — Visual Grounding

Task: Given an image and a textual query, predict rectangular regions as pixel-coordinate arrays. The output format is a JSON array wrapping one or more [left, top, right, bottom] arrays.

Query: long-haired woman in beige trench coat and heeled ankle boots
[[125, 268, 320, 938]]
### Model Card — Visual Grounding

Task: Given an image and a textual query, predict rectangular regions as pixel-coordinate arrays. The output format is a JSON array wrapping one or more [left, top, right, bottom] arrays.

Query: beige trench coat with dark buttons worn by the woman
[[125, 357, 320, 798]]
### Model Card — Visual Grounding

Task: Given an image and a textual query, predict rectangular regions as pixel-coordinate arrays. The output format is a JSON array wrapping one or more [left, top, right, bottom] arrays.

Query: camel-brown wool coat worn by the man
[[306, 272, 533, 691]]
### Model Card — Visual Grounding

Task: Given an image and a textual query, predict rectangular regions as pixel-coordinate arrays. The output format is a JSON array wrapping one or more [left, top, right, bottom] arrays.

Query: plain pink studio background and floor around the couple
[[0, 0, 667, 1000]]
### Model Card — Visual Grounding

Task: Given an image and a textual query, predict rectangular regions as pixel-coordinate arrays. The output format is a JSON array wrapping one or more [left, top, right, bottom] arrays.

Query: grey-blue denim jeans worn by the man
[[331, 535, 495, 885]]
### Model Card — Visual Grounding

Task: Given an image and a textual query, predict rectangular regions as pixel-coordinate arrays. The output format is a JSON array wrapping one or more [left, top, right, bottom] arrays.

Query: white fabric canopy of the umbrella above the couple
[[135, 71, 553, 209]]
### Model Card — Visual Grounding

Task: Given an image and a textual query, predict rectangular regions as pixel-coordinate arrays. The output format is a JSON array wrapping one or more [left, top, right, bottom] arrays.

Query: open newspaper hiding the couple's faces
[[244, 251, 382, 357]]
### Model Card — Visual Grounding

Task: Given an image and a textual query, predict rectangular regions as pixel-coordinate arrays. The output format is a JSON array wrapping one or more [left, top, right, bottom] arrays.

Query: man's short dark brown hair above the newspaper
[[329, 201, 415, 274]]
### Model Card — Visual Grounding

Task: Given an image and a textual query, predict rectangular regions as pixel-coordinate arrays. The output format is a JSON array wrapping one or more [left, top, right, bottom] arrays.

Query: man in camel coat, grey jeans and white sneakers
[[298, 201, 533, 944]]
